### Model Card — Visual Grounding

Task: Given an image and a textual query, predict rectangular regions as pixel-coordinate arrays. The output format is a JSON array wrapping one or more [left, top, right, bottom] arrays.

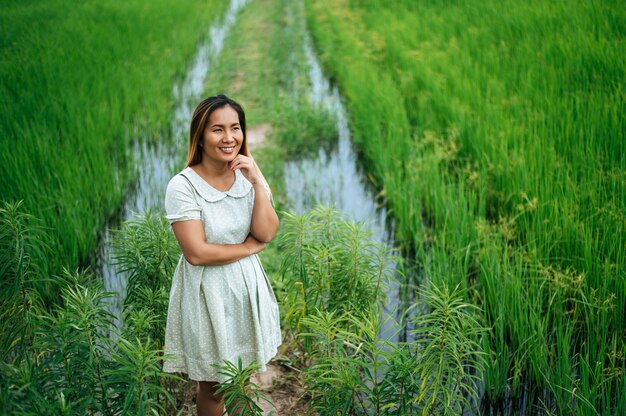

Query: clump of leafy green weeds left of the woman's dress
[[0, 210, 193, 416]]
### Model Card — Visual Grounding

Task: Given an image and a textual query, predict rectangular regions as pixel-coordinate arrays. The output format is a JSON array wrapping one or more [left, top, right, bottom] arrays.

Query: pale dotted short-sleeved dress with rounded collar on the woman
[[163, 167, 282, 382]]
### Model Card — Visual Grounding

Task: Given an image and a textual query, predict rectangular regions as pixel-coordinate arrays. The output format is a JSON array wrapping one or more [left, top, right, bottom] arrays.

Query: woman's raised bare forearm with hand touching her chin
[[230, 155, 278, 243]]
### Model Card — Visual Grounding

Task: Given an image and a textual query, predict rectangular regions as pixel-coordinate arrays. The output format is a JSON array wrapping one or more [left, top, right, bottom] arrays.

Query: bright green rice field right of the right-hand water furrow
[[306, 0, 626, 414]]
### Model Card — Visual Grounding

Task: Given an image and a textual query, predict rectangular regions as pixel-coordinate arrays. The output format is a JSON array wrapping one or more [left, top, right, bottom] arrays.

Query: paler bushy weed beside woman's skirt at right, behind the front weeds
[[280, 205, 395, 348]]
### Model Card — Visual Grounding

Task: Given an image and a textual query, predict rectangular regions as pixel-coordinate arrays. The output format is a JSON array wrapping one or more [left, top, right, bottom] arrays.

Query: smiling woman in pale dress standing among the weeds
[[163, 95, 281, 416]]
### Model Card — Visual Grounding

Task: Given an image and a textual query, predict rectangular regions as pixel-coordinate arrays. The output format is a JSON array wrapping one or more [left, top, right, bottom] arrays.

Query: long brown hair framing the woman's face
[[187, 94, 250, 166]]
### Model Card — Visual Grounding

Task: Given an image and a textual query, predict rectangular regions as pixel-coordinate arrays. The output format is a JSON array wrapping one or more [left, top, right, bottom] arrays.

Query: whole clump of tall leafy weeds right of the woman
[[279, 206, 486, 415]]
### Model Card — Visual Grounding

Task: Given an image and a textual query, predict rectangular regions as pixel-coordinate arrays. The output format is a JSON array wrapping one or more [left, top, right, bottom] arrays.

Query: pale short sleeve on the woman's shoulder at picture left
[[165, 175, 202, 224]]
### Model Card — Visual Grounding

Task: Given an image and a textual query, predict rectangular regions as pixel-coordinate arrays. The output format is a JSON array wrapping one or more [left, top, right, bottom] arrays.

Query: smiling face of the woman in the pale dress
[[202, 105, 243, 163]]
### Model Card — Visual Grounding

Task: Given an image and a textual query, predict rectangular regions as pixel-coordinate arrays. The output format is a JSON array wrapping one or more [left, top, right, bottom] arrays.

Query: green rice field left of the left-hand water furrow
[[0, 0, 225, 286]]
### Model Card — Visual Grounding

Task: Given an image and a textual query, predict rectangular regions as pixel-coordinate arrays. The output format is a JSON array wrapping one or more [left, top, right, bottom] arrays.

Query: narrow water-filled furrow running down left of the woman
[[99, 0, 248, 323]]
